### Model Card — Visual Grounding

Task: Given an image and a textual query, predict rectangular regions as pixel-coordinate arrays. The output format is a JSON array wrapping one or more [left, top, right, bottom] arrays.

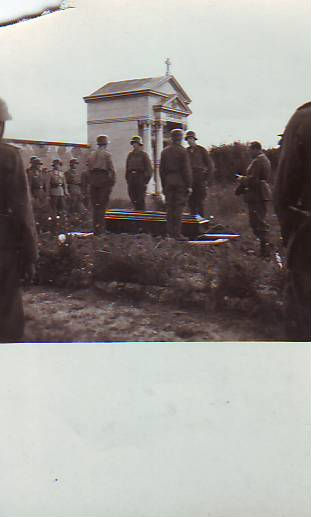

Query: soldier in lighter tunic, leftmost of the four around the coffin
[[88, 135, 116, 235]]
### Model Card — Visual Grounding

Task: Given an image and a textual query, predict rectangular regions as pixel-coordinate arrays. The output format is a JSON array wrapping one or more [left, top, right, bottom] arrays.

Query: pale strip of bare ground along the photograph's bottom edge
[[24, 286, 282, 342]]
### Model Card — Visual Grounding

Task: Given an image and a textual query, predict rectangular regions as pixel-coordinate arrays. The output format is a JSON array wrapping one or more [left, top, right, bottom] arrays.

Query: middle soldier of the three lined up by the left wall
[[46, 158, 68, 217]]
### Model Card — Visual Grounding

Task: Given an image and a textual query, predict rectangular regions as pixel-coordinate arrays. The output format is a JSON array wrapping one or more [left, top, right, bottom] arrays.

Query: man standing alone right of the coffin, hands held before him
[[236, 142, 272, 257]]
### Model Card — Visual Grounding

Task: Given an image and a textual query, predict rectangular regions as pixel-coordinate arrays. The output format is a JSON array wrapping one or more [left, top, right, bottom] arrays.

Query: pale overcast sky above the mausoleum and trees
[[0, 0, 311, 146]]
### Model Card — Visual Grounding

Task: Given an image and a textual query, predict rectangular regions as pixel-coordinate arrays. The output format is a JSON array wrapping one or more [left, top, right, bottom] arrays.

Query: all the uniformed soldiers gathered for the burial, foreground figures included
[[0, 92, 311, 342]]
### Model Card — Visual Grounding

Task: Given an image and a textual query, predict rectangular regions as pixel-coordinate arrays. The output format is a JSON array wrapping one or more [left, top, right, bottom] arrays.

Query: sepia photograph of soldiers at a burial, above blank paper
[[0, 0, 311, 342]]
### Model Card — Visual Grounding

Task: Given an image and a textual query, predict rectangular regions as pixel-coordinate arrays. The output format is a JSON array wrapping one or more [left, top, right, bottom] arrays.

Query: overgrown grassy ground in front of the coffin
[[24, 186, 285, 342]]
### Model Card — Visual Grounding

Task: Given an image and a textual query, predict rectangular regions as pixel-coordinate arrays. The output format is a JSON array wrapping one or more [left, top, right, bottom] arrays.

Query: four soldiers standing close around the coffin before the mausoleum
[[88, 129, 214, 240]]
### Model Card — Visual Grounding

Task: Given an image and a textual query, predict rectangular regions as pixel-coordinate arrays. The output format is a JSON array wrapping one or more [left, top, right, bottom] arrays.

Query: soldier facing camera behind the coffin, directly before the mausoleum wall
[[125, 136, 153, 210]]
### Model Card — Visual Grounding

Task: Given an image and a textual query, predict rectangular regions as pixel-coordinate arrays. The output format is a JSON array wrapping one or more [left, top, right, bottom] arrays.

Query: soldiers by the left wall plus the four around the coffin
[[27, 129, 214, 240]]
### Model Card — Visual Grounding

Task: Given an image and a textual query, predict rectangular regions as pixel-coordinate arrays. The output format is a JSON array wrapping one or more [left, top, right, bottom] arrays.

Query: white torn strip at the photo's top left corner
[[0, 0, 74, 28]]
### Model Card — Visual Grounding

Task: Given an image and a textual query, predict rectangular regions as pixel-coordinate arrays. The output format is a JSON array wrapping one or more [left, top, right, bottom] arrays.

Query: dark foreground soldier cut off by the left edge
[[0, 99, 37, 343]]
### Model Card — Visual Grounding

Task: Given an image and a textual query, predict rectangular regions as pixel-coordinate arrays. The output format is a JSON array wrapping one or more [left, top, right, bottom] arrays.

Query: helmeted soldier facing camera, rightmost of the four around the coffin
[[185, 131, 214, 217]]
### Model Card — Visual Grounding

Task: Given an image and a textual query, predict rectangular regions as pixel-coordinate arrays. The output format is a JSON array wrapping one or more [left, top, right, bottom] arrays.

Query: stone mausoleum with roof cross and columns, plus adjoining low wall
[[5, 63, 191, 198]]
